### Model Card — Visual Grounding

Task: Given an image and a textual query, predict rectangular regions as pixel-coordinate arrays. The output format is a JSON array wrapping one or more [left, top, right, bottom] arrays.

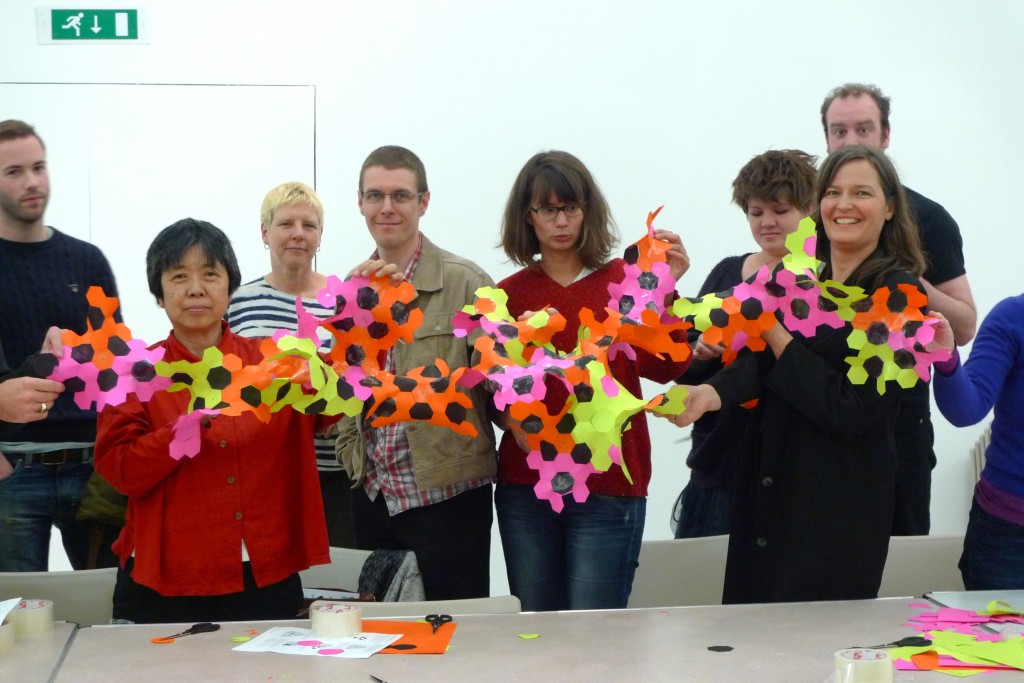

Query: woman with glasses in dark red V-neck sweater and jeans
[[495, 152, 689, 611]]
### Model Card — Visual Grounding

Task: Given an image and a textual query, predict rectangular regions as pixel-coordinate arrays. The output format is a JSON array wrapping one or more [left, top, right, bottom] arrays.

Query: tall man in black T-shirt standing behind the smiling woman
[[821, 83, 978, 536]]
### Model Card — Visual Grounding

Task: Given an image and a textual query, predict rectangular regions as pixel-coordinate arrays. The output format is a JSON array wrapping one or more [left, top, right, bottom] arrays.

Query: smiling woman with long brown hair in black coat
[[675, 146, 926, 603]]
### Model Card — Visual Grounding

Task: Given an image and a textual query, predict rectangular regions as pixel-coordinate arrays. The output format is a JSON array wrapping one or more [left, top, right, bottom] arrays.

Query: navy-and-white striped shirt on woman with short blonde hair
[[225, 278, 341, 472]]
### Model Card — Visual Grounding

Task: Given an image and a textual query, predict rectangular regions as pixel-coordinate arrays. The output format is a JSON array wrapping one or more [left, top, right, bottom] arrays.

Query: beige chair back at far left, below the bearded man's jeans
[[0, 567, 118, 627]]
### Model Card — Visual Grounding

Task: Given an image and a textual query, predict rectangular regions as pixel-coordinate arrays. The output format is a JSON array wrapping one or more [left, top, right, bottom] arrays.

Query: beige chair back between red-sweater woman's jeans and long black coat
[[628, 536, 729, 607]]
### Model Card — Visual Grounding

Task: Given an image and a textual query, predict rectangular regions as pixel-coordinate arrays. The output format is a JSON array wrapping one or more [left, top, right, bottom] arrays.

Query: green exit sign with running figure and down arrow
[[36, 7, 150, 44]]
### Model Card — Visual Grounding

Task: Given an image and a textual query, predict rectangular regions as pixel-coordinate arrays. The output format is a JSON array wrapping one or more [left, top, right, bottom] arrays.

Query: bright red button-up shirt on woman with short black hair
[[95, 325, 336, 596]]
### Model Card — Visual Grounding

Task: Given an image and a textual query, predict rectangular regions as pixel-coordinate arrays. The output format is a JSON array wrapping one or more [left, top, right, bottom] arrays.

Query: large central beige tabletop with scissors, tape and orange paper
[[49, 598, 1020, 683]]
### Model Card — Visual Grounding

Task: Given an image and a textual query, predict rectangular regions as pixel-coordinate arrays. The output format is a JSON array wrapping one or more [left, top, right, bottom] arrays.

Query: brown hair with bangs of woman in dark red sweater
[[502, 151, 618, 270]]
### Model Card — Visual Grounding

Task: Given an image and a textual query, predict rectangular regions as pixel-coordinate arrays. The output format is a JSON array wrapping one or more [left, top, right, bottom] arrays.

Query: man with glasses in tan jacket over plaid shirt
[[337, 146, 498, 600]]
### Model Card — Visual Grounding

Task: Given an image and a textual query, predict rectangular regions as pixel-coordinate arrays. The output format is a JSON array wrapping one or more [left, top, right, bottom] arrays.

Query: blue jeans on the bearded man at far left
[[0, 456, 92, 571]]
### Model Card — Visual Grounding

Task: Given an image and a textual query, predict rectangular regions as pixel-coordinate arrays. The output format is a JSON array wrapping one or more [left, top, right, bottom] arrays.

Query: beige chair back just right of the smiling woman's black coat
[[879, 536, 964, 598]]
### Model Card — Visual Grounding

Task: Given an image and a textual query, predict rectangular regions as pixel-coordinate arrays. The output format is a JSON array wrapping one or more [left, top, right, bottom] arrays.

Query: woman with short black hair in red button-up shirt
[[95, 218, 336, 623]]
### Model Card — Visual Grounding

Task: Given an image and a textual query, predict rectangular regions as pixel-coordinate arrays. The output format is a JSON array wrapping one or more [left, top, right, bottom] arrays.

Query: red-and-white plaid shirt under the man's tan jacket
[[362, 236, 490, 516]]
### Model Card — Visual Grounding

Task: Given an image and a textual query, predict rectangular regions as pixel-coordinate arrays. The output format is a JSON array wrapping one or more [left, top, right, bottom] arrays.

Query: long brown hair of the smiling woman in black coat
[[814, 144, 925, 292]]
